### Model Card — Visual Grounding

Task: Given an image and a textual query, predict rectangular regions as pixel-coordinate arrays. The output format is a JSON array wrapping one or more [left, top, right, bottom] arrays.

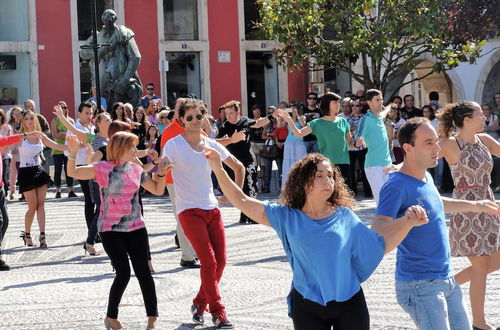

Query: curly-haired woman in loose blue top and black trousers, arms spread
[[201, 147, 427, 330]]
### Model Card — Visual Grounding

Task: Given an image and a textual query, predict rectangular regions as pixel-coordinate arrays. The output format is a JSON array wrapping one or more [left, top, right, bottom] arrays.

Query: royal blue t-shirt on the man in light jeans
[[376, 172, 450, 281]]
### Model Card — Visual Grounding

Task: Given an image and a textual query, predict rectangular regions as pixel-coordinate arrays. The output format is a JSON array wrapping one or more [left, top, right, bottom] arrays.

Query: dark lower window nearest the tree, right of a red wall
[[246, 52, 279, 113]]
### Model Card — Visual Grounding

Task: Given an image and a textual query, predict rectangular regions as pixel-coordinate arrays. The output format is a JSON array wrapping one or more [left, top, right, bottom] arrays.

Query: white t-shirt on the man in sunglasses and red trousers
[[162, 134, 230, 214]]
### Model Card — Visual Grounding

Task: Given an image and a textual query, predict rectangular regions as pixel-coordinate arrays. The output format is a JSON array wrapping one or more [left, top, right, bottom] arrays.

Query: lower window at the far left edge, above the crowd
[[0, 53, 31, 105]]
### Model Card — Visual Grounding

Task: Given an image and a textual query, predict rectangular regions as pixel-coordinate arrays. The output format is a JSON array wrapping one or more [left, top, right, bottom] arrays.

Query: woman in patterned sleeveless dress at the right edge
[[439, 101, 500, 329]]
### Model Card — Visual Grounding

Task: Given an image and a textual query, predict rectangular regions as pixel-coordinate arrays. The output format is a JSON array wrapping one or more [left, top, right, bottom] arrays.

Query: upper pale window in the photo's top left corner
[[0, 0, 30, 41]]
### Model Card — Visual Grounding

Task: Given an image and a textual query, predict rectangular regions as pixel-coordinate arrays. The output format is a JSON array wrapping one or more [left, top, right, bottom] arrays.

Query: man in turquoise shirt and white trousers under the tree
[[355, 89, 392, 203]]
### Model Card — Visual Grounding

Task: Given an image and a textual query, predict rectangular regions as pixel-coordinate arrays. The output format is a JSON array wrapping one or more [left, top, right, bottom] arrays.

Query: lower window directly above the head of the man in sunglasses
[[165, 52, 201, 109]]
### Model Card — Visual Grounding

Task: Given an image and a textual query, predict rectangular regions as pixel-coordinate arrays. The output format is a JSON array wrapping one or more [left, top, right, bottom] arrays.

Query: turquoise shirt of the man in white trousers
[[358, 111, 392, 168]]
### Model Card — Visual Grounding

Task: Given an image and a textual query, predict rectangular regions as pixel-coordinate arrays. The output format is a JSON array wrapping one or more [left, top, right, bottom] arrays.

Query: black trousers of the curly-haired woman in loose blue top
[[291, 288, 370, 330]]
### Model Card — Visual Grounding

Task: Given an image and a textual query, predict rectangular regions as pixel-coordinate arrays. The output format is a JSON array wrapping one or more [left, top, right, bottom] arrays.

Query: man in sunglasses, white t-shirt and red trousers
[[163, 99, 245, 329]]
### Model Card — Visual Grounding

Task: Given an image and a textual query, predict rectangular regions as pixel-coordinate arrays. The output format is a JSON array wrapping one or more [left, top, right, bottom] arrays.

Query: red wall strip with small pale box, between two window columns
[[208, 0, 241, 116]]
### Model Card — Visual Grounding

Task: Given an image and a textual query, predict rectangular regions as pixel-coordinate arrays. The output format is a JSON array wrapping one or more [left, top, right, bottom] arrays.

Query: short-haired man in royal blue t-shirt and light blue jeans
[[372, 117, 499, 330]]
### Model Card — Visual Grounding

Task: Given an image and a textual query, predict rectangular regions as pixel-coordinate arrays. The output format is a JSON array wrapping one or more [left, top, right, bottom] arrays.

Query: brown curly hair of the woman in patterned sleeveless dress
[[437, 101, 480, 138]]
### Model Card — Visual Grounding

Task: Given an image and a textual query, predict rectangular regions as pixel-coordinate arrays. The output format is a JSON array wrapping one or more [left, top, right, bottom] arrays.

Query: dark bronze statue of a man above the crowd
[[80, 9, 142, 106]]
